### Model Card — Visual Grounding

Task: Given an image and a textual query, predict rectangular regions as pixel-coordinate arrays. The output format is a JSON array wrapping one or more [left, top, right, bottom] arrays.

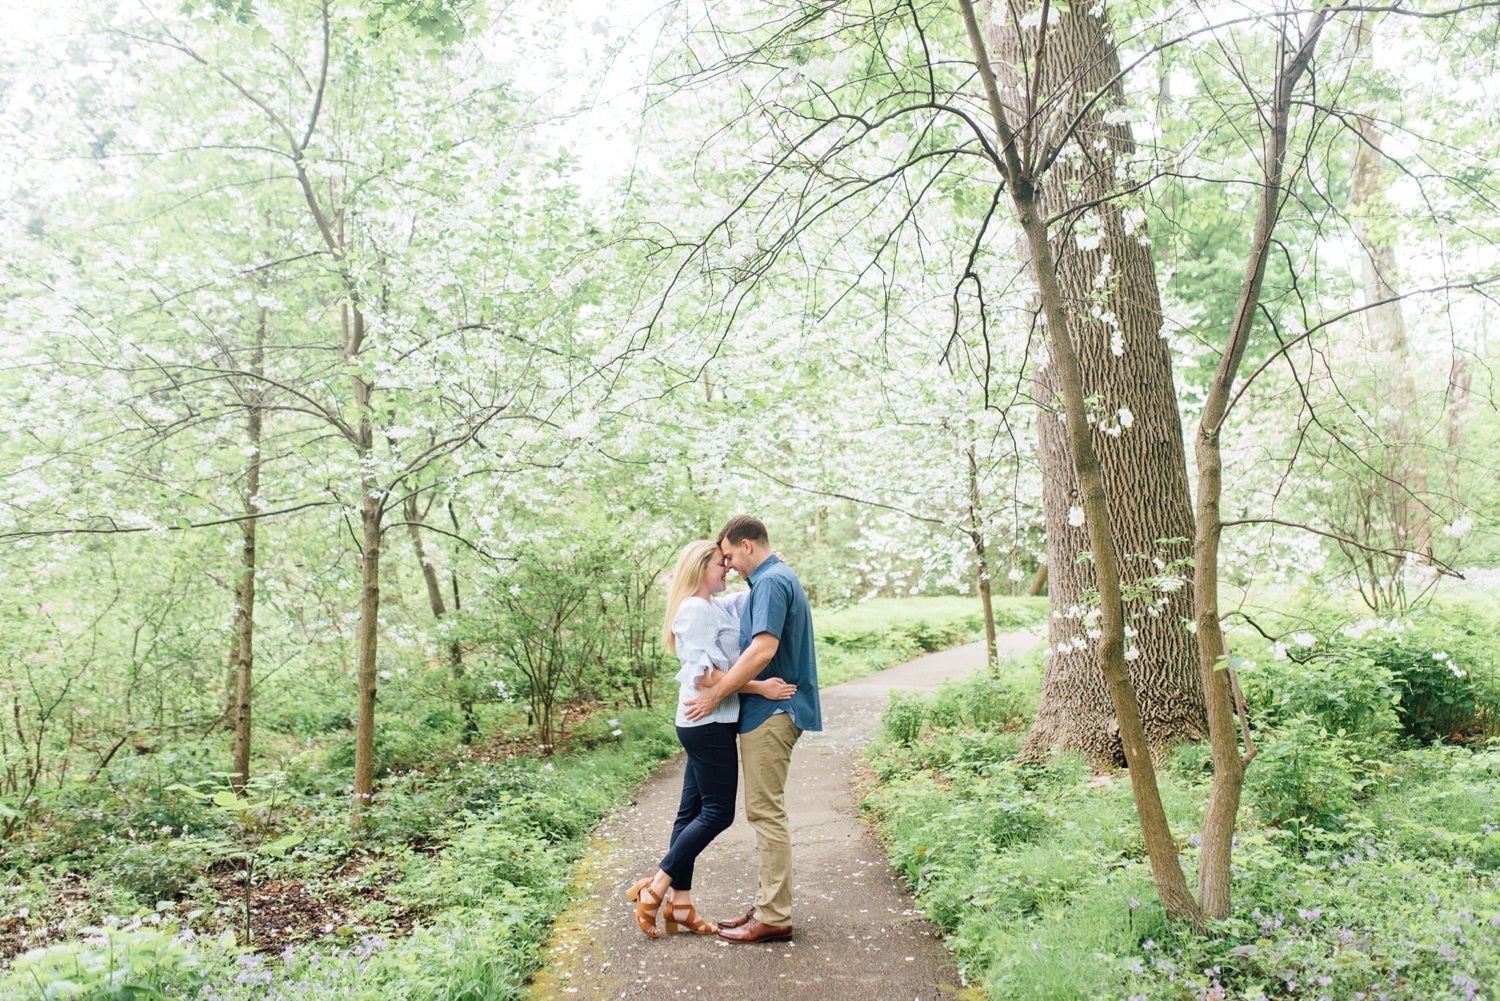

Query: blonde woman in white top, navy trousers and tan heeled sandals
[[626, 539, 797, 938]]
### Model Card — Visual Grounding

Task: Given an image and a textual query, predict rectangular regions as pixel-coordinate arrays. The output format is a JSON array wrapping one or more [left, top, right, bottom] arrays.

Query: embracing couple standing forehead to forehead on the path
[[629, 515, 824, 942]]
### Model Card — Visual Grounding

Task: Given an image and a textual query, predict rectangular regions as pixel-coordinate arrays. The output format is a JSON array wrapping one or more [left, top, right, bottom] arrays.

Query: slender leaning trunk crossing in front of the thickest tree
[[959, 0, 1203, 924]]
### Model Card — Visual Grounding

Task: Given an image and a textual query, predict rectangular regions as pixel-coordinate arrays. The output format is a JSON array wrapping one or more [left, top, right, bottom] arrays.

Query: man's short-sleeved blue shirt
[[740, 557, 824, 734]]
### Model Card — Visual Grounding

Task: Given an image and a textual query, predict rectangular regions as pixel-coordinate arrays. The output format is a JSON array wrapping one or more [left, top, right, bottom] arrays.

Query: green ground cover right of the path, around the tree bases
[[866, 605, 1500, 1001]]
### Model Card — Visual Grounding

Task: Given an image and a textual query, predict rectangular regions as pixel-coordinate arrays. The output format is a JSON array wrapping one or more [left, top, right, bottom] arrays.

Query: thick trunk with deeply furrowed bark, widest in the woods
[[987, 3, 1208, 768]]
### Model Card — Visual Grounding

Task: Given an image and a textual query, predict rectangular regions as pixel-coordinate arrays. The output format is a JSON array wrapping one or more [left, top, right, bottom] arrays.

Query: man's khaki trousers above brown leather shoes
[[740, 713, 803, 924]]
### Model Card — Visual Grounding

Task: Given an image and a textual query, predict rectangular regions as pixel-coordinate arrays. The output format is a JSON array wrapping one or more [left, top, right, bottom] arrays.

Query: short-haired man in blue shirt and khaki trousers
[[686, 515, 824, 942]]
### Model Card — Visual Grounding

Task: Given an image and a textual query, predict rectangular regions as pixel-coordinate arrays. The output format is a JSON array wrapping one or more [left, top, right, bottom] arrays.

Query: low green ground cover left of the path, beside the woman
[[0, 708, 677, 998]]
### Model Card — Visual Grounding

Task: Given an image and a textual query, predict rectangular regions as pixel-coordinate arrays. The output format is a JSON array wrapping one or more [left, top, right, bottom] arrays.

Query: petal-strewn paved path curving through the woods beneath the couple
[[533, 632, 1037, 1001]]
